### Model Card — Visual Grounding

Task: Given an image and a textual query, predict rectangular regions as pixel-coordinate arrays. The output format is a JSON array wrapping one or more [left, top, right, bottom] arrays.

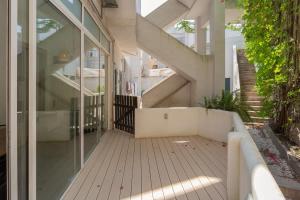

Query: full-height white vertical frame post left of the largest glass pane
[[28, 0, 37, 200]]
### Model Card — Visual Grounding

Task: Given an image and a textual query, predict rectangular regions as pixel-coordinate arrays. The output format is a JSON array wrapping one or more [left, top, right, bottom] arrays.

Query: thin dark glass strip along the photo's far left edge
[[0, 0, 8, 199]]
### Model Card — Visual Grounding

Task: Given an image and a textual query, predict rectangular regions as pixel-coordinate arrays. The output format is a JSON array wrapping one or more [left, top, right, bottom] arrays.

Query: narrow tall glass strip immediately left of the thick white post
[[17, 0, 29, 200]]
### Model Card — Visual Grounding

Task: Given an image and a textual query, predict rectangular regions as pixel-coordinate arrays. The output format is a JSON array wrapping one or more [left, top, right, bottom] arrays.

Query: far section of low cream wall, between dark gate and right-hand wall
[[135, 107, 232, 142]]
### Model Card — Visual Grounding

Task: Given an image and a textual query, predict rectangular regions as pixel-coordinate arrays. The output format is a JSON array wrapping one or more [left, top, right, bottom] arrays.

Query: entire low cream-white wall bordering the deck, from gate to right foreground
[[135, 107, 285, 200]]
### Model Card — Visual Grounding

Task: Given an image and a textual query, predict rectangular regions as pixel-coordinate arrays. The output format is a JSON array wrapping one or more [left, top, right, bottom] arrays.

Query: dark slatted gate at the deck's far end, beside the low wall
[[114, 95, 138, 134]]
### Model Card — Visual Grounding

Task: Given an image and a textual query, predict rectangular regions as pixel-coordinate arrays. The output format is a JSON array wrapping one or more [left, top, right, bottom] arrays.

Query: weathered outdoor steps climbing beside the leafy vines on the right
[[237, 49, 267, 123]]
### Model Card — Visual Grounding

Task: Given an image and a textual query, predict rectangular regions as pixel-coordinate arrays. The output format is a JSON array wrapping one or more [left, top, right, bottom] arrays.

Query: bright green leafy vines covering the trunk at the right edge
[[242, 0, 300, 132]]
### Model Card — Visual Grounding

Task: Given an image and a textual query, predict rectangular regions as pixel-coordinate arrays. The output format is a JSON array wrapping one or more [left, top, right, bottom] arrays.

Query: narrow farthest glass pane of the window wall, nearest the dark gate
[[100, 51, 108, 132]]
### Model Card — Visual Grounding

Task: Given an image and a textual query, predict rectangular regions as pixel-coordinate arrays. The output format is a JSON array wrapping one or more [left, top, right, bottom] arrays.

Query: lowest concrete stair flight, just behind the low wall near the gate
[[142, 73, 190, 108]]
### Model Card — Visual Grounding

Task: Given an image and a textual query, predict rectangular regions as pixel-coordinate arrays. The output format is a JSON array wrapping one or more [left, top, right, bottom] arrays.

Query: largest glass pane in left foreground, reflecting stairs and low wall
[[36, 0, 81, 200]]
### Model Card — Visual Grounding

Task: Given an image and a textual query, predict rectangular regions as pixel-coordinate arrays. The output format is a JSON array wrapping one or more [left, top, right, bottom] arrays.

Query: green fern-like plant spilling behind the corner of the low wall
[[204, 90, 251, 121]]
